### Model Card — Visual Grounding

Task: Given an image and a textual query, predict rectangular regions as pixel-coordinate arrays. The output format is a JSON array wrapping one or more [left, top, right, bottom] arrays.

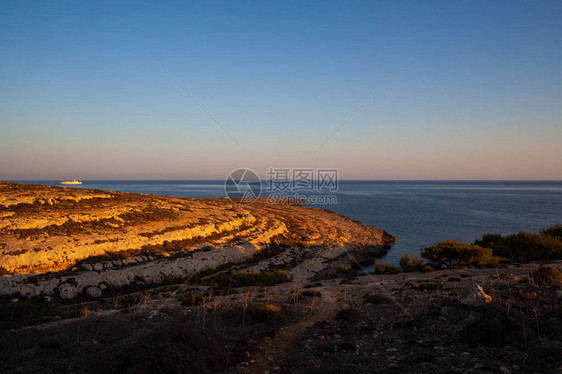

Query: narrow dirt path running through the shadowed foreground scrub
[[246, 285, 341, 374]]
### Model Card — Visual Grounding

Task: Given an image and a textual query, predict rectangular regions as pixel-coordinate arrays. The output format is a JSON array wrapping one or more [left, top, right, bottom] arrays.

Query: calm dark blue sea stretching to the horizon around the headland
[[18, 181, 562, 264]]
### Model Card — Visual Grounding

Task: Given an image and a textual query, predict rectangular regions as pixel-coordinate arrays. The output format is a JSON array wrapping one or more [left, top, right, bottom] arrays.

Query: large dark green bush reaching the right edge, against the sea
[[474, 224, 562, 261]]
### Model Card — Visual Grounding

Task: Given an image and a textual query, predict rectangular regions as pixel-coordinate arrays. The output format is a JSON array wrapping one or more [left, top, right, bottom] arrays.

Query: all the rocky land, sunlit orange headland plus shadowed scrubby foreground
[[0, 183, 562, 374]]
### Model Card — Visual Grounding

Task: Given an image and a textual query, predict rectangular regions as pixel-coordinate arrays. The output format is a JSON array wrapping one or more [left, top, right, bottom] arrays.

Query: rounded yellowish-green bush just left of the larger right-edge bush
[[421, 240, 499, 268]]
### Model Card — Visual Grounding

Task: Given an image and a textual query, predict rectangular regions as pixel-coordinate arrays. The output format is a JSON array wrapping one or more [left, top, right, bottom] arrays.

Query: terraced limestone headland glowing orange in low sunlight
[[0, 182, 394, 297]]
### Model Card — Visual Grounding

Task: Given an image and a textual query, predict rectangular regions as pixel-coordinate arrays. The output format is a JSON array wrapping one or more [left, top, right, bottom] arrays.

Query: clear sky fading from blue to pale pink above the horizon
[[0, 1, 562, 180]]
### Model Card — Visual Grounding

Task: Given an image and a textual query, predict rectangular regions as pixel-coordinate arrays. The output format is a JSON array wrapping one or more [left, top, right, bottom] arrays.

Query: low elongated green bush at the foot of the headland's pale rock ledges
[[209, 270, 292, 289]]
